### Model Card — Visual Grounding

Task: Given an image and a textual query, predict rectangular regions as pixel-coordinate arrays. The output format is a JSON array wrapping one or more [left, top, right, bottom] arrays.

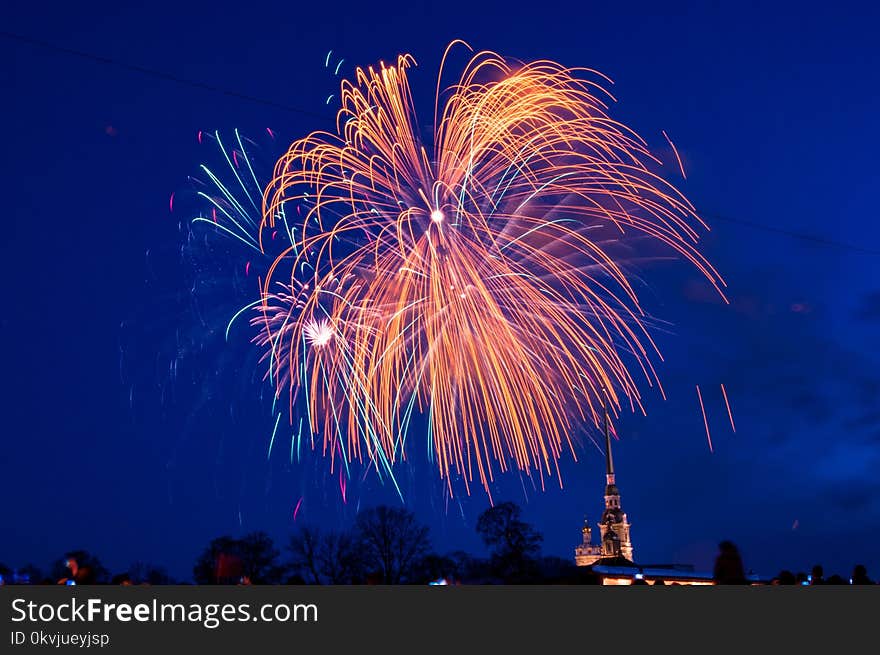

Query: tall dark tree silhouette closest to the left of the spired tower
[[477, 502, 544, 582]]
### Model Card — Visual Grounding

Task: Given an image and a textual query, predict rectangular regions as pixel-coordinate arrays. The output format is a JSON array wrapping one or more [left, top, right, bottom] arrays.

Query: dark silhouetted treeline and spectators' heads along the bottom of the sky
[[0, 502, 874, 585]]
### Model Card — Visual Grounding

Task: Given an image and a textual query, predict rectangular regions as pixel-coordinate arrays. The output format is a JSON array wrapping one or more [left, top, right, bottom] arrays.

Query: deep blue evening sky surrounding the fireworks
[[0, 0, 880, 576]]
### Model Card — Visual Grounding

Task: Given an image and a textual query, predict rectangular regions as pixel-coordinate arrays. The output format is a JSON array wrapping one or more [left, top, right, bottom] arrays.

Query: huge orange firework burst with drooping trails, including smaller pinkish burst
[[255, 42, 724, 490]]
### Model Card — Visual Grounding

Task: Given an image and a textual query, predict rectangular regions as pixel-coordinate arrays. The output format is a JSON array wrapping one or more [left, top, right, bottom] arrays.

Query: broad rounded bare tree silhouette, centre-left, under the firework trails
[[355, 505, 430, 584]]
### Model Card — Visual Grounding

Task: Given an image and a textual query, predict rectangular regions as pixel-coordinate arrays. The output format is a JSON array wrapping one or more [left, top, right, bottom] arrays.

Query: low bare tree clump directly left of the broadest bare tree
[[288, 526, 364, 584]]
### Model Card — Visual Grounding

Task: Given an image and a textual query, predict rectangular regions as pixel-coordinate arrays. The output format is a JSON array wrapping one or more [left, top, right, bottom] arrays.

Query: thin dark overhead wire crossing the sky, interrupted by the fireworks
[[0, 31, 880, 255]]
